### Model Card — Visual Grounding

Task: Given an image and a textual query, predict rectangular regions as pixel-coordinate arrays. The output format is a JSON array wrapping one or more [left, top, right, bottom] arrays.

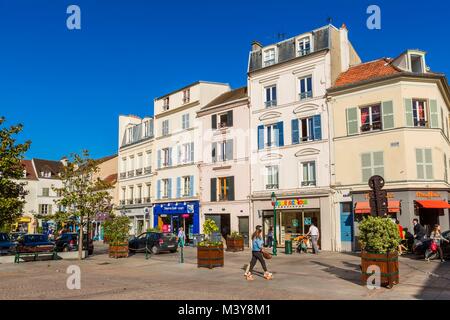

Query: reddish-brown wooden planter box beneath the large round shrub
[[361, 250, 400, 288]]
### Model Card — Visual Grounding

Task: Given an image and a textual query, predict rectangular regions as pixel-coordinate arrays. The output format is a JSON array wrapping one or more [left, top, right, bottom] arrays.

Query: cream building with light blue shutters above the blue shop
[[153, 81, 230, 239]]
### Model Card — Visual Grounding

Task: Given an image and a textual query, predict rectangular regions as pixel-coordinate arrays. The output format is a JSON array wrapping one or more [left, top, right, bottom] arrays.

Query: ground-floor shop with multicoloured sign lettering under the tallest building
[[253, 196, 335, 250]]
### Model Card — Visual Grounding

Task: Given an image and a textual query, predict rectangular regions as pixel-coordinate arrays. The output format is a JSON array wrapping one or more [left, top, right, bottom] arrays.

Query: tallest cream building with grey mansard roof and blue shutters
[[248, 25, 360, 250]]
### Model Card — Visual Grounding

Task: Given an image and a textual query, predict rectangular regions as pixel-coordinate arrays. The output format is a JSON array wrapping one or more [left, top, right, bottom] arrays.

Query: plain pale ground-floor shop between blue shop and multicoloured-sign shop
[[201, 201, 251, 246]]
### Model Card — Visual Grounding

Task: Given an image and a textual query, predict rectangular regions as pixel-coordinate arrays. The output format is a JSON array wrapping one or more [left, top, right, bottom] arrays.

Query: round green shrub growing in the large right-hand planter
[[359, 216, 401, 253]]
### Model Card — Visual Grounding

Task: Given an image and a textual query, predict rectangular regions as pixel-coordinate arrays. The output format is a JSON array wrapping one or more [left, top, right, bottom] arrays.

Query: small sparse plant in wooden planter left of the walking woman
[[197, 219, 224, 269]]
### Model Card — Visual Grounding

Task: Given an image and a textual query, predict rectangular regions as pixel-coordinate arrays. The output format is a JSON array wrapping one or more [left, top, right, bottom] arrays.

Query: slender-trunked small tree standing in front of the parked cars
[[54, 150, 112, 259]]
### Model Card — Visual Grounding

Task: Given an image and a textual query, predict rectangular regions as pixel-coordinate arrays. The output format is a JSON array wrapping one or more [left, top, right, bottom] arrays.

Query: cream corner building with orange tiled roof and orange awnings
[[328, 50, 450, 250]]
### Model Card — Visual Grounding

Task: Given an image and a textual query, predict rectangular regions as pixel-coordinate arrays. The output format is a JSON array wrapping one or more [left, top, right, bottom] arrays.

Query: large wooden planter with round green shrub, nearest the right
[[359, 216, 401, 288]]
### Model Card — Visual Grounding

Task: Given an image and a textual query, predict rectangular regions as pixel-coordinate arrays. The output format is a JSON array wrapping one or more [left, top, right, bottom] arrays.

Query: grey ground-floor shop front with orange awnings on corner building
[[353, 190, 450, 250]]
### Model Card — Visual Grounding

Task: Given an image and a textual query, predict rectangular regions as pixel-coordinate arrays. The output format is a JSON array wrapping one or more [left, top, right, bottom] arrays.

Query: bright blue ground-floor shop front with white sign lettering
[[153, 201, 200, 240]]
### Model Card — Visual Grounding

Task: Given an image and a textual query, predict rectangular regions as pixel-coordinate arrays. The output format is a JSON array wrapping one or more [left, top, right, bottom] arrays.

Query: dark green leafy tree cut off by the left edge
[[0, 117, 31, 228]]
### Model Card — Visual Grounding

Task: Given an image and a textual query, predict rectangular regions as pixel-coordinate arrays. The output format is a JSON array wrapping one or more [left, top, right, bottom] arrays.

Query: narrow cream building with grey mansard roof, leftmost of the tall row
[[117, 115, 154, 235]]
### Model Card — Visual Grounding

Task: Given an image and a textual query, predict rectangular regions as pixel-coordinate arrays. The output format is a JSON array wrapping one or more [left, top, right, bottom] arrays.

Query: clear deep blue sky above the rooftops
[[0, 0, 450, 160]]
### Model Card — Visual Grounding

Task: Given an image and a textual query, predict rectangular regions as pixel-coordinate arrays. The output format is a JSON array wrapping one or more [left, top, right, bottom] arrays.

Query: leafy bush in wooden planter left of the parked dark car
[[104, 216, 130, 258]]
